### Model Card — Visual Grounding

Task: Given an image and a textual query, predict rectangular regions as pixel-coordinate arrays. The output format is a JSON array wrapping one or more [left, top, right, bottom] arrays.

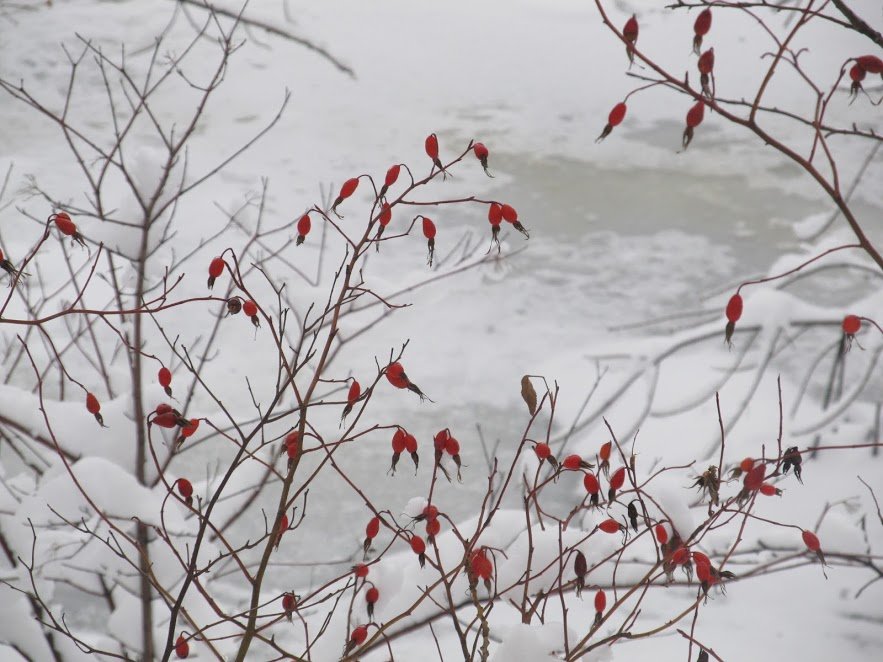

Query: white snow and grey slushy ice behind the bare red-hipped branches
[[0, 0, 883, 662]]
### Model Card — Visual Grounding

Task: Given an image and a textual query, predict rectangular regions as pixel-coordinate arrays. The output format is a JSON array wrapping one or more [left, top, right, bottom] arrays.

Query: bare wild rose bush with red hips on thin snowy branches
[[0, 3, 883, 660]]
